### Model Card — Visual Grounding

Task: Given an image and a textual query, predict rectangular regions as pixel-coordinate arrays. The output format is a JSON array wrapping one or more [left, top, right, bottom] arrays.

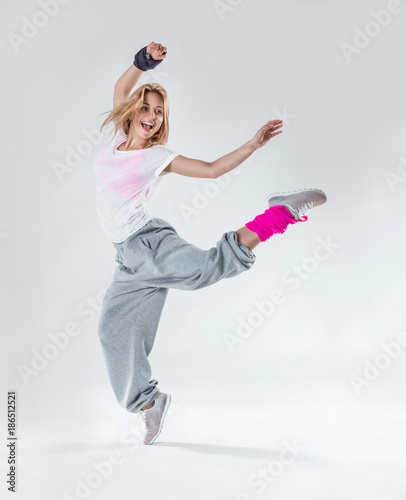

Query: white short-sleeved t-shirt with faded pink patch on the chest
[[93, 131, 179, 243]]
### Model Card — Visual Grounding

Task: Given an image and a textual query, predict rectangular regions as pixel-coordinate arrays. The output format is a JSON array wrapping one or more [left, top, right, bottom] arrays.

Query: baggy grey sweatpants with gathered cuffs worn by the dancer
[[98, 218, 256, 413]]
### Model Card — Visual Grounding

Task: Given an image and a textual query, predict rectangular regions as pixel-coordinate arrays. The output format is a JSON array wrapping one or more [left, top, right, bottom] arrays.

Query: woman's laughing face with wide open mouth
[[132, 92, 164, 139]]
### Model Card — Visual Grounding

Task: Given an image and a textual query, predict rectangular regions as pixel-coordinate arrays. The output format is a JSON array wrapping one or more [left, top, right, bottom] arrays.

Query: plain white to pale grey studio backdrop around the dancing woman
[[0, 0, 406, 500]]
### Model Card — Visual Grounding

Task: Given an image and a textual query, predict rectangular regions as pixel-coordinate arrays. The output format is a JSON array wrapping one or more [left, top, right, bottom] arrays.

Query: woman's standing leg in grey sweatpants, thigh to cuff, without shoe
[[98, 265, 168, 413]]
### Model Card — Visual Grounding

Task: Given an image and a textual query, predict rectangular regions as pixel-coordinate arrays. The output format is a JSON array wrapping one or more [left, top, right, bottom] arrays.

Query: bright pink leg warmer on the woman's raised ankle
[[245, 205, 307, 241]]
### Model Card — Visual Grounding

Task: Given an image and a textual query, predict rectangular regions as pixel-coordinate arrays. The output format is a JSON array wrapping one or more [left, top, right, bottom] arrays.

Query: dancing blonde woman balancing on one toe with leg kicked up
[[94, 42, 327, 444]]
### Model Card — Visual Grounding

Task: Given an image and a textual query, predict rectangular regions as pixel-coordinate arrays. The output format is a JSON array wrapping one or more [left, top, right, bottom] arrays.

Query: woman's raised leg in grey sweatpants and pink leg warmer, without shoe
[[120, 202, 298, 290]]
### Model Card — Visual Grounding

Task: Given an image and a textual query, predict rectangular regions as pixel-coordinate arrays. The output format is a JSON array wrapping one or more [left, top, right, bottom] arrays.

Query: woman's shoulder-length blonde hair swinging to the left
[[100, 83, 169, 147]]
